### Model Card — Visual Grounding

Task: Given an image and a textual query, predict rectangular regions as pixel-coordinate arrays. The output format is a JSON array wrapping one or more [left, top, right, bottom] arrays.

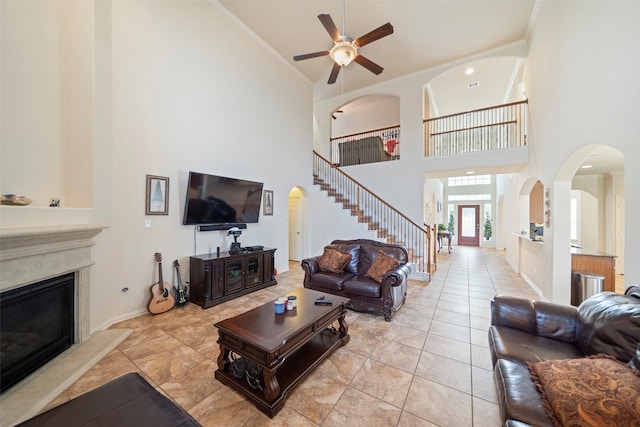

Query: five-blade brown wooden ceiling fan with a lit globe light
[[293, 14, 393, 84]]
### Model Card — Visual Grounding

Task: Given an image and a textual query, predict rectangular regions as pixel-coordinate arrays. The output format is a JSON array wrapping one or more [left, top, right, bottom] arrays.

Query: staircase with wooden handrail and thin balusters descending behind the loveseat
[[313, 151, 435, 280]]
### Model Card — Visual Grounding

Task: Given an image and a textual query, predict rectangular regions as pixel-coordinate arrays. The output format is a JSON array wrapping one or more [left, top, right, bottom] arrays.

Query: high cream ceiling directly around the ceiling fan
[[220, 0, 535, 101]]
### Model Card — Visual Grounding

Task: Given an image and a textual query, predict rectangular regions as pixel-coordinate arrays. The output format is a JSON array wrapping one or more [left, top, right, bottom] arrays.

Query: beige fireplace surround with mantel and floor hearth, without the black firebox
[[0, 224, 136, 426]]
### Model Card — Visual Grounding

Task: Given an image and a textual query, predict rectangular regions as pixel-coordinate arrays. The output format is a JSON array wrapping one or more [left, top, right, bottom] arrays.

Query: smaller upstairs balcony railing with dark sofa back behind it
[[331, 125, 400, 166]]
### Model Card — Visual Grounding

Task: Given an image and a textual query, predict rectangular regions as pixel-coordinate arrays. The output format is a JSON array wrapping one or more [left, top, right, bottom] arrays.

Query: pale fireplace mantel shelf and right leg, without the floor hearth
[[0, 224, 107, 343]]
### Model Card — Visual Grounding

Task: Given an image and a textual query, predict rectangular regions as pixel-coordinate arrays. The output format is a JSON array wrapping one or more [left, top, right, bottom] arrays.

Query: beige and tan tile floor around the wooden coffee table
[[45, 246, 539, 427]]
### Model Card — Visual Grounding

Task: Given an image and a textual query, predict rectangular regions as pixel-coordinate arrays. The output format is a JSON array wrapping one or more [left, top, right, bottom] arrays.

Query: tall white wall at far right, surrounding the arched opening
[[526, 2, 640, 303]]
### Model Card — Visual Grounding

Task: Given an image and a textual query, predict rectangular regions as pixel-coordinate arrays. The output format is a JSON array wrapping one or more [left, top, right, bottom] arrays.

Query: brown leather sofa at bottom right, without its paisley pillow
[[489, 286, 640, 427]]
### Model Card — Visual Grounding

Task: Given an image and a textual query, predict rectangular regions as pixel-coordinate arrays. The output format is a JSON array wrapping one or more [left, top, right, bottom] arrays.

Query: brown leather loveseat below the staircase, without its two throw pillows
[[301, 239, 411, 322]]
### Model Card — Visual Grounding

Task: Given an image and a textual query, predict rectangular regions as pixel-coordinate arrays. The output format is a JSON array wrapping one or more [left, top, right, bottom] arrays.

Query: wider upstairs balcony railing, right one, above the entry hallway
[[424, 100, 528, 157]]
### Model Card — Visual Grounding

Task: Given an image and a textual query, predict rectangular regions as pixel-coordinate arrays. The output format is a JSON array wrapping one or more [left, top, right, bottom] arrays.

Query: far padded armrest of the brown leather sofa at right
[[491, 296, 578, 343]]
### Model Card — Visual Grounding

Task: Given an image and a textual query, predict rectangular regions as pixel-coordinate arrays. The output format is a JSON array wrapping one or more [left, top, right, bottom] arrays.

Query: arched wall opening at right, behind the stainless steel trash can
[[551, 144, 625, 296]]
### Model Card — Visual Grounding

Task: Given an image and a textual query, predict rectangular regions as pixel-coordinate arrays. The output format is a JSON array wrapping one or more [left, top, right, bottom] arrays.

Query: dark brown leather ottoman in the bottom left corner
[[19, 372, 200, 427]]
